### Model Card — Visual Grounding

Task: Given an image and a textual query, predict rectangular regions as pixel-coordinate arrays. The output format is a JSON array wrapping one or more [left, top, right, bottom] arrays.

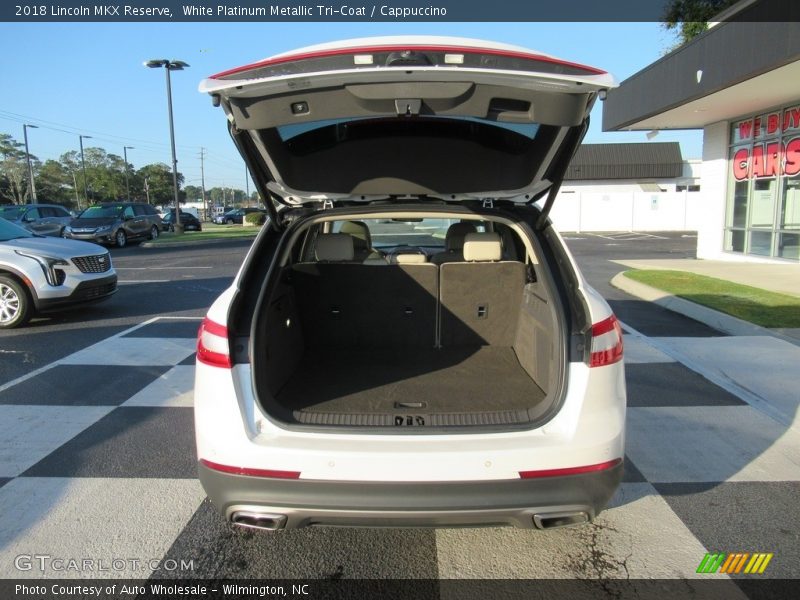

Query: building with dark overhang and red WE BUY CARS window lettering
[[603, 0, 800, 262]]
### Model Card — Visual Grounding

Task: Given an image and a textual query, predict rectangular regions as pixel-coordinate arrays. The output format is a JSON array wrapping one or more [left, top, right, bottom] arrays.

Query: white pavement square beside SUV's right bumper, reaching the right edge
[[625, 406, 800, 483]]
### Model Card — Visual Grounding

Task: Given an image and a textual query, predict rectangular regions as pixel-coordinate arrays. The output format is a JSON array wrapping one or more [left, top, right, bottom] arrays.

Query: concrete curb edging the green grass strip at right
[[611, 272, 800, 346]]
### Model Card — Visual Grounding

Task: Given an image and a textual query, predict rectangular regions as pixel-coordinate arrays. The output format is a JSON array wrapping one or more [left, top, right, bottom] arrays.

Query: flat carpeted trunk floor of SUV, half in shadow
[[276, 346, 545, 414]]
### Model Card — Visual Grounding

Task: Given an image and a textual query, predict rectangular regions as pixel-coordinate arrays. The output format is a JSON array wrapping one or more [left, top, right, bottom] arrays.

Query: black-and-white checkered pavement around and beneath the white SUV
[[0, 318, 800, 578]]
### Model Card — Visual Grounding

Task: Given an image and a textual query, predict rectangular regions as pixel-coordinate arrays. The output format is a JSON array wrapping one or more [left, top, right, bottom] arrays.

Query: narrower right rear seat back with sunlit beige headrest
[[439, 233, 525, 347]]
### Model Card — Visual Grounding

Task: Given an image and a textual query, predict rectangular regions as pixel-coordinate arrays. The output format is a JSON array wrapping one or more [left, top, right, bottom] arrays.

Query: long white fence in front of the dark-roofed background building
[[550, 192, 703, 231]]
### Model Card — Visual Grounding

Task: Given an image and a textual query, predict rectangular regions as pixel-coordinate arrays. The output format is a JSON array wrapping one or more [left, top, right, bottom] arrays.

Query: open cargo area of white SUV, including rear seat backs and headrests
[[254, 216, 557, 427]]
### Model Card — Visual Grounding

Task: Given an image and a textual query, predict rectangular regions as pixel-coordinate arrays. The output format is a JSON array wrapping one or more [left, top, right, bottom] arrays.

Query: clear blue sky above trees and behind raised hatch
[[0, 22, 702, 191]]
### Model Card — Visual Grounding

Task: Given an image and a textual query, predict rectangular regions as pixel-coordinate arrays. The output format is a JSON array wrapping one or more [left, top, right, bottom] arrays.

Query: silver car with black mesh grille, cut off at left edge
[[0, 218, 117, 329]]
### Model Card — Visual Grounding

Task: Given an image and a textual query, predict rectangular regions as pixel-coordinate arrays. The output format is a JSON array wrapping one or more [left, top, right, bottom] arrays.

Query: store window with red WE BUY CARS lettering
[[725, 104, 800, 260]]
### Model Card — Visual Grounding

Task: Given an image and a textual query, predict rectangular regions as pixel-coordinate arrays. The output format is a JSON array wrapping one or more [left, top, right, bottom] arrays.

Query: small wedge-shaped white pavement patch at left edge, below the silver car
[[0, 406, 115, 476]]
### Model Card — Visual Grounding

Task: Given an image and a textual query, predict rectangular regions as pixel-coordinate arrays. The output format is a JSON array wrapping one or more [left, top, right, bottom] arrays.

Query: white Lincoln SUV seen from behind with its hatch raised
[[195, 37, 625, 530]]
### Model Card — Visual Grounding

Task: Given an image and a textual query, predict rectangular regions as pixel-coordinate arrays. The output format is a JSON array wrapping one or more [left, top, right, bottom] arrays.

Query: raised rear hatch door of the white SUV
[[200, 36, 615, 222]]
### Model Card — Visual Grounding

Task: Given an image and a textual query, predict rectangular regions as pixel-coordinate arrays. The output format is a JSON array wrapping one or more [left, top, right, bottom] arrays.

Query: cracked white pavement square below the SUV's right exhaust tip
[[436, 483, 742, 580]]
